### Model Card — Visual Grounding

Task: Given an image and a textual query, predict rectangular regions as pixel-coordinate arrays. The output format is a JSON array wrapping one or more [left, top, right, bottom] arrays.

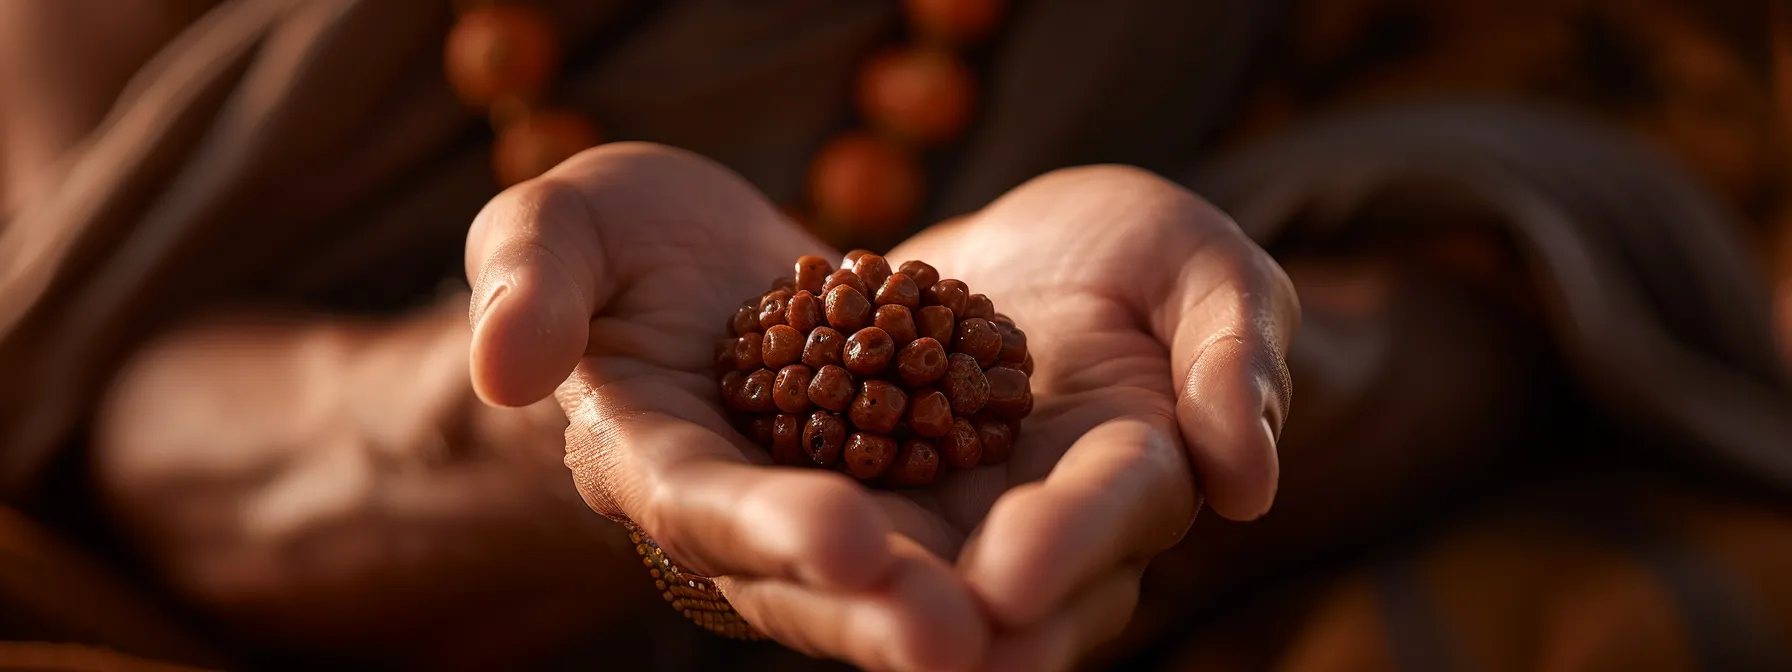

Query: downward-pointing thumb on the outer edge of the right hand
[[1154, 210, 1301, 520]]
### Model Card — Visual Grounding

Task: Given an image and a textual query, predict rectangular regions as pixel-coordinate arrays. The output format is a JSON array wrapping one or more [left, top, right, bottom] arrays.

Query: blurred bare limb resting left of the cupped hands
[[90, 306, 663, 668]]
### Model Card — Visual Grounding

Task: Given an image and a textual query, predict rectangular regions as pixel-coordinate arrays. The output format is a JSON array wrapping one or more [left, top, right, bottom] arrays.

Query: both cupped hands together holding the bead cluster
[[468, 143, 1299, 668]]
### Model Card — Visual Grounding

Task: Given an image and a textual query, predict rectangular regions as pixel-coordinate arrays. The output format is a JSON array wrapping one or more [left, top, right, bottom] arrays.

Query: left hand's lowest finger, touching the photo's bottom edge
[[717, 534, 989, 670]]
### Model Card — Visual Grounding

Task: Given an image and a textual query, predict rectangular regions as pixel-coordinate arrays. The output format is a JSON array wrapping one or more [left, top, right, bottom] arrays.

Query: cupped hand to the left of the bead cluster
[[466, 143, 987, 668]]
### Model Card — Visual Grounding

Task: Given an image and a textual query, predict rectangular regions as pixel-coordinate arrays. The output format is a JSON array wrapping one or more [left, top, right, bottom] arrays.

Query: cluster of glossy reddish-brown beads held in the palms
[[713, 251, 1034, 487]]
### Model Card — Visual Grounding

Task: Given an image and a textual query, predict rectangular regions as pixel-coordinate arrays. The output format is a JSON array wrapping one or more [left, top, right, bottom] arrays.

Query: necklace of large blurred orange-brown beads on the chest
[[444, 0, 1004, 238]]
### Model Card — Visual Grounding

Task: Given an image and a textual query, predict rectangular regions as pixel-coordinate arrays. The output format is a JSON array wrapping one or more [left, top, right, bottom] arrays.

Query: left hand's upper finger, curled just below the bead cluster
[[561, 371, 894, 590]]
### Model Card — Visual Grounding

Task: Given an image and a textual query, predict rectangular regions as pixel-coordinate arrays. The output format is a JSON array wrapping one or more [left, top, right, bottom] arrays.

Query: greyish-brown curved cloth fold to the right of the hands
[[1193, 100, 1792, 493]]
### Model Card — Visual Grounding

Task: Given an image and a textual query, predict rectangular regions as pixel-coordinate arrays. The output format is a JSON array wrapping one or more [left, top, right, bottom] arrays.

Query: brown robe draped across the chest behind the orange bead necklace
[[0, 0, 1279, 502]]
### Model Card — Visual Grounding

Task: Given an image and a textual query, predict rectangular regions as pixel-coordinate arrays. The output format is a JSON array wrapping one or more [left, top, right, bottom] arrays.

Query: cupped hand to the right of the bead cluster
[[891, 167, 1299, 670]]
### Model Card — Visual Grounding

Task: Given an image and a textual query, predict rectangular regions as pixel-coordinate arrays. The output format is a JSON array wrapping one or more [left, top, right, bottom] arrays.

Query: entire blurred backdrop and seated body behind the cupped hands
[[0, 0, 1792, 670]]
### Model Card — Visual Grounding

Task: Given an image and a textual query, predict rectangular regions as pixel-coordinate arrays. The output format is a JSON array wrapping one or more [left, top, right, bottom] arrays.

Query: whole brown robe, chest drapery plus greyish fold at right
[[0, 0, 1792, 670]]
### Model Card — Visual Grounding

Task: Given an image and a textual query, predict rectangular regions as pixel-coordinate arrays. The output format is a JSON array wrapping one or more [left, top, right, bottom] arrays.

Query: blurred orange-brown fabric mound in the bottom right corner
[[1275, 489, 1792, 672]]
